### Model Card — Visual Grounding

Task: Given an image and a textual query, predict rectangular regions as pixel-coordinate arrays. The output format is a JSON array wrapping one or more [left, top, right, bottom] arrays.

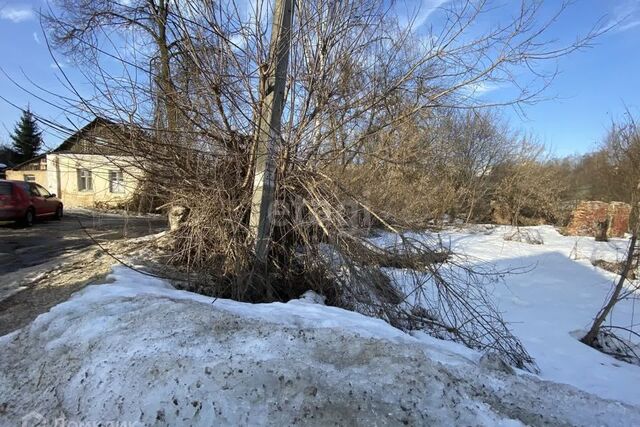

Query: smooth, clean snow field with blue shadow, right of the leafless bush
[[374, 226, 640, 405]]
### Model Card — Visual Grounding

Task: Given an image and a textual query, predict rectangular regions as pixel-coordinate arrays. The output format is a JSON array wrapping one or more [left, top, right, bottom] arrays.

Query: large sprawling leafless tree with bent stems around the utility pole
[[33, 0, 601, 372]]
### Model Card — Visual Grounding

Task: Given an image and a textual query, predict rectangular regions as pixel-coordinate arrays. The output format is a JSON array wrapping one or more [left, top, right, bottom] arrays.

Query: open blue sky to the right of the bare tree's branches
[[500, 0, 640, 155]]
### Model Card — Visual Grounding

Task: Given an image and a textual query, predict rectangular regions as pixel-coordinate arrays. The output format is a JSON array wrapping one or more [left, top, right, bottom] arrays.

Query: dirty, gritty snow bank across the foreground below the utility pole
[[0, 267, 640, 426]]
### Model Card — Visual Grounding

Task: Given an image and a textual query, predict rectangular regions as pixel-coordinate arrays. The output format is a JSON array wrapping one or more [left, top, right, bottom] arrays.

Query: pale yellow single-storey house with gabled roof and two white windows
[[6, 118, 141, 207]]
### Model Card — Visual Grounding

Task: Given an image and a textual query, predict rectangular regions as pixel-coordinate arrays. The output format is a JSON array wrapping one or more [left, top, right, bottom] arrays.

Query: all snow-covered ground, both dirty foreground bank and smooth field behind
[[0, 227, 640, 426]]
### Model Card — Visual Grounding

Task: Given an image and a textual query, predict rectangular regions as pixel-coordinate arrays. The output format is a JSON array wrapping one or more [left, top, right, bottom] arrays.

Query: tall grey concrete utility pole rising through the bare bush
[[249, 0, 293, 262]]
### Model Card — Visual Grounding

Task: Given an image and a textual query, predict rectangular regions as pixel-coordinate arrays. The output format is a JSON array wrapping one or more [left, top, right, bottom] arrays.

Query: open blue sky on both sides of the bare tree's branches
[[0, 0, 640, 156]]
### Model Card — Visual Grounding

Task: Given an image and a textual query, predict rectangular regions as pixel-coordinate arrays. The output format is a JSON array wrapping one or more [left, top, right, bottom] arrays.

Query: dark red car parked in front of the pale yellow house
[[0, 180, 62, 227]]
